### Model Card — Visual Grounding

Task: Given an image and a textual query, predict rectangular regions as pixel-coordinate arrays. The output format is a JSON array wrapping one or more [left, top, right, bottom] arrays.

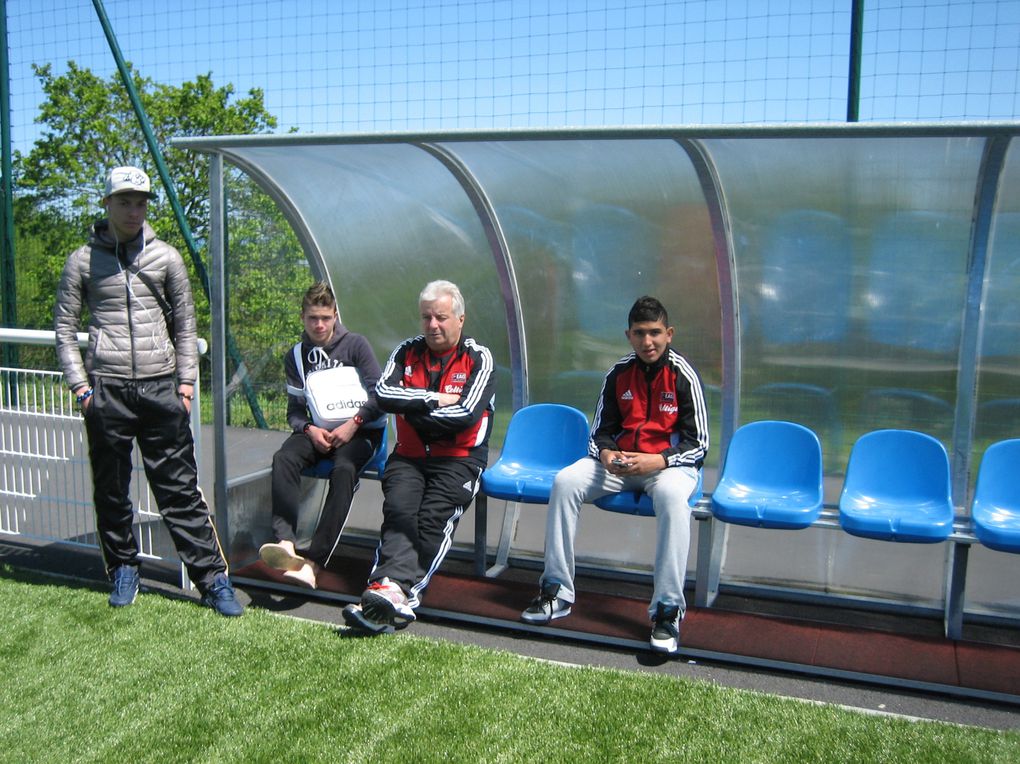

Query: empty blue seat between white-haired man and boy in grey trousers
[[481, 403, 589, 504]]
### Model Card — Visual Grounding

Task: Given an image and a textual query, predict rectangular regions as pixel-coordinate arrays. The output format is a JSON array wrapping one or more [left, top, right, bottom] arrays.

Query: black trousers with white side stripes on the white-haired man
[[369, 454, 482, 608]]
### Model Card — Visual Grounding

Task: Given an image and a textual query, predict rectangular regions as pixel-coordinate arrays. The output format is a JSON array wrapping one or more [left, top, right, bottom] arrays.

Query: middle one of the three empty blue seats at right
[[839, 429, 953, 544]]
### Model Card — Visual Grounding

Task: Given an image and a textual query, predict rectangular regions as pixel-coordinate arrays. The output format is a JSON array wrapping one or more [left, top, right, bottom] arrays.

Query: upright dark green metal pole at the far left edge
[[0, 0, 18, 366]]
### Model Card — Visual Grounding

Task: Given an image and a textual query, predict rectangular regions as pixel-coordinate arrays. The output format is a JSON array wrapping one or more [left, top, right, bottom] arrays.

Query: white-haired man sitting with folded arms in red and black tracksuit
[[344, 282, 496, 633]]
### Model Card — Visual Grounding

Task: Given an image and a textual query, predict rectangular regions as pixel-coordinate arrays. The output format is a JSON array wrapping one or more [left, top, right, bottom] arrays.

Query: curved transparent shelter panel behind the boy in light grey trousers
[[447, 140, 721, 446]]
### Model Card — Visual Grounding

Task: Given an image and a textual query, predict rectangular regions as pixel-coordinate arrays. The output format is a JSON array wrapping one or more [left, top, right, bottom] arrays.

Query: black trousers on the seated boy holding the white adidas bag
[[272, 427, 383, 566]]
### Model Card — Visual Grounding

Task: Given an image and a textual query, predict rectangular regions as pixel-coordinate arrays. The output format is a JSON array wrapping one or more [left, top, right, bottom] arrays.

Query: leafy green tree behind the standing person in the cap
[[14, 61, 276, 340]]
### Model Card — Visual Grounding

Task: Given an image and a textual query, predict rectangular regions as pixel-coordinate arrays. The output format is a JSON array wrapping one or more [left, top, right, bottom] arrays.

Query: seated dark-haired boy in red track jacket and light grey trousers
[[521, 297, 709, 653]]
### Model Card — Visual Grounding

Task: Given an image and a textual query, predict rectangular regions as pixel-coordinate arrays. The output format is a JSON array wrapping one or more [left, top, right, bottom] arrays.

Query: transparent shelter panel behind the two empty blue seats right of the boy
[[706, 138, 983, 606]]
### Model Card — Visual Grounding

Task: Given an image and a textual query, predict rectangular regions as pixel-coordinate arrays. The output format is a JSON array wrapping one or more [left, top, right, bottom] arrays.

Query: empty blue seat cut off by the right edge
[[971, 439, 1020, 553]]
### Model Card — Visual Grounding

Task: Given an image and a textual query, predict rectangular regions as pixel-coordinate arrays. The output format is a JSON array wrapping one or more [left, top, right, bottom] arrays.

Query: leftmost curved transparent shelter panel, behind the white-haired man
[[221, 144, 511, 428]]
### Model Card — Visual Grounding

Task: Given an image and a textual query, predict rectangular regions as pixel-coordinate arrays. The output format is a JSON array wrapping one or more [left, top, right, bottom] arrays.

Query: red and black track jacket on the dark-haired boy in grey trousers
[[588, 347, 709, 468]]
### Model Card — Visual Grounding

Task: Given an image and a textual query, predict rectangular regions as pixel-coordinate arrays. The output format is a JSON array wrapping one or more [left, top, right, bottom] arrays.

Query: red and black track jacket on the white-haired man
[[375, 335, 496, 467]]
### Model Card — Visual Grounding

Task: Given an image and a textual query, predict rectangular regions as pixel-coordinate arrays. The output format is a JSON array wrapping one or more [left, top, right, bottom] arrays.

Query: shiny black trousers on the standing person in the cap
[[85, 376, 226, 592]]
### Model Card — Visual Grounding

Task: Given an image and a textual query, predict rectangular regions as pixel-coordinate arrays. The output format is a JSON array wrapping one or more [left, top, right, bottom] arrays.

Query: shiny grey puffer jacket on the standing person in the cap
[[53, 220, 198, 390]]
